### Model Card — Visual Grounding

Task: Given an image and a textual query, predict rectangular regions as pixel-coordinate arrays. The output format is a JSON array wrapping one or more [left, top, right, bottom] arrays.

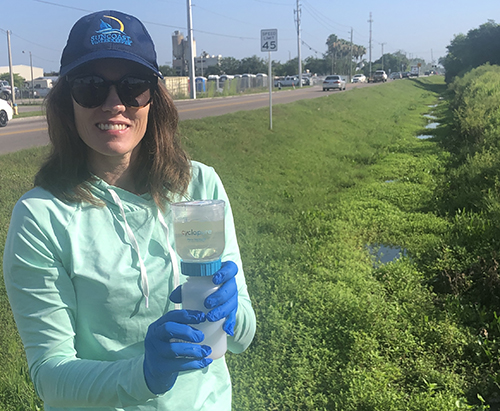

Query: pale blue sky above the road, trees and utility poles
[[0, 0, 500, 71]]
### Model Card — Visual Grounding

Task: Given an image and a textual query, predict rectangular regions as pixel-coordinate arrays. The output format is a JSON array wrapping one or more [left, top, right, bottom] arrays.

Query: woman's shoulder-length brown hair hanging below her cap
[[35, 78, 191, 210]]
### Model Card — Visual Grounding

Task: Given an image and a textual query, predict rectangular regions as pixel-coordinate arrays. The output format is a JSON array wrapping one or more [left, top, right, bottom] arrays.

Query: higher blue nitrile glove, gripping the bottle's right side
[[170, 261, 238, 336]]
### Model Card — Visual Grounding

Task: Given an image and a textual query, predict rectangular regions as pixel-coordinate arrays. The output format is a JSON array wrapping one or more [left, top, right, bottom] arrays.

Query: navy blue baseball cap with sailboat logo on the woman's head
[[59, 10, 163, 78]]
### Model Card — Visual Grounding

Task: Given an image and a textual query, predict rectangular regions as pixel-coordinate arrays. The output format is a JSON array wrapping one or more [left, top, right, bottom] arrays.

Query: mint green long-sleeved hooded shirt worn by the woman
[[3, 162, 256, 411]]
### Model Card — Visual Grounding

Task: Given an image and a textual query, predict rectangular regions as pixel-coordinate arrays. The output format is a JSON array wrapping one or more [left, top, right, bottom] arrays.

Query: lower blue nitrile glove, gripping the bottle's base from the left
[[144, 310, 212, 395]]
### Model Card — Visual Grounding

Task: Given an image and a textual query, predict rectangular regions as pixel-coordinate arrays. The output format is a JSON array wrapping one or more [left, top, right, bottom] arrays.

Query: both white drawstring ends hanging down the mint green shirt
[[108, 188, 180, 310]]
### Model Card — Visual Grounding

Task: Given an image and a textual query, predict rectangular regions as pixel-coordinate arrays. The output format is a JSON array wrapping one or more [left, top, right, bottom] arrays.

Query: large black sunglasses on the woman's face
[[68, 74, 158, 108]]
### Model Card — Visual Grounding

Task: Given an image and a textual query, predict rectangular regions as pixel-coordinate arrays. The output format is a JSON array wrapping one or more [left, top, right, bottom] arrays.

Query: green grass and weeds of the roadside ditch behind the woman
[[0, 77, 492, 411]]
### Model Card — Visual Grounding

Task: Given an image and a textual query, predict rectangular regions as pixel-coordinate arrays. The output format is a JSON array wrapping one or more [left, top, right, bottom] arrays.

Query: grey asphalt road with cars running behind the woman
[[0, 83, 376, 154]]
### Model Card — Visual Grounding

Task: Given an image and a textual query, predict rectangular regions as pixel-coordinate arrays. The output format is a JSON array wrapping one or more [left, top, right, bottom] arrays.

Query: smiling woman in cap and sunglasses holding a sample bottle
[[3, 11, 255, 411]]
